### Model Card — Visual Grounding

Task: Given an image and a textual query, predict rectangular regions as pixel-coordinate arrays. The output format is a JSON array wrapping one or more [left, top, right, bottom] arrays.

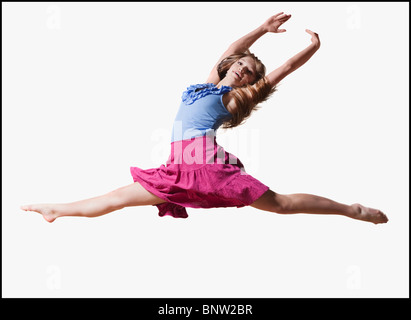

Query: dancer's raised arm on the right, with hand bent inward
[[266, 29, 320, 87]]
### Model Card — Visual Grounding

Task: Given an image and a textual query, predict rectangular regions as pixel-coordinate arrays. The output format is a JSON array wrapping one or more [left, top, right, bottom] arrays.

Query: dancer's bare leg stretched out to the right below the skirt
[[251, 190, 388, 224]]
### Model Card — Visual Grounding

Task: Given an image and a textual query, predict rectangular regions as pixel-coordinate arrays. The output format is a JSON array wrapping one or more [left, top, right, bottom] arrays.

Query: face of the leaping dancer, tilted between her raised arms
[[226, 57, 257, 87]]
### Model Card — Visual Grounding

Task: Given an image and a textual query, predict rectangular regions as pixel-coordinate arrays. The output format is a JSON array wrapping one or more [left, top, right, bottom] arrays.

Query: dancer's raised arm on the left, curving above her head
[[207, 12, 291, 84]]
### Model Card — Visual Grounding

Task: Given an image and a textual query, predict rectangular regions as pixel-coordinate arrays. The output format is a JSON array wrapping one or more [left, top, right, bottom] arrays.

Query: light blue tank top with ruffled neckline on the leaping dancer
[[171, 83, 232, 142]]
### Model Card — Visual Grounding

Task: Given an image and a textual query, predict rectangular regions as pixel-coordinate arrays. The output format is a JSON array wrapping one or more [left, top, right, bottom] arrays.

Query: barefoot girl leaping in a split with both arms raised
[[21, 12, 388, 224]]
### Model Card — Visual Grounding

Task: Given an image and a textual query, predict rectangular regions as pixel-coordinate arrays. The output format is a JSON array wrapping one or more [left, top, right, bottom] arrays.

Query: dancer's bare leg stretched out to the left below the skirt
[[21, 182, 165, 222]]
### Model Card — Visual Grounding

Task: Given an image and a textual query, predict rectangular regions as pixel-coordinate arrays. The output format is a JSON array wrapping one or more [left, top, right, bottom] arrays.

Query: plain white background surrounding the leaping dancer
[[2, 2, 409, 298]]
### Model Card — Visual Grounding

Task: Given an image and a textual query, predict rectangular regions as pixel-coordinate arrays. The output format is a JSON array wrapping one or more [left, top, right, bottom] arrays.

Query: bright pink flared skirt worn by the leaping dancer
[[130, 135, 269, 218]]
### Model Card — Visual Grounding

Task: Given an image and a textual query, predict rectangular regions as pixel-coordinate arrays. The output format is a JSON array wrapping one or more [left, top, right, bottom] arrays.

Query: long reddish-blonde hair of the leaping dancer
[[217, 50, 277, 129]]
